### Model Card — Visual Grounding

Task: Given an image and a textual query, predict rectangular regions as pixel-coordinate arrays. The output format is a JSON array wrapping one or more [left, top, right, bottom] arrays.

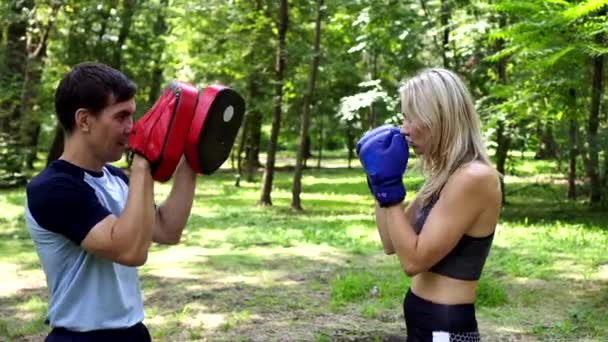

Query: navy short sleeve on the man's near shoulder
[[26, 176, 111, 245]]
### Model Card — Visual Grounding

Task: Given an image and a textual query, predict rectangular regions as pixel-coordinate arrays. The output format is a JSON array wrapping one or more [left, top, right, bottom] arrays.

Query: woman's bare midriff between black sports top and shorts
[[411, 272, 477, 305]]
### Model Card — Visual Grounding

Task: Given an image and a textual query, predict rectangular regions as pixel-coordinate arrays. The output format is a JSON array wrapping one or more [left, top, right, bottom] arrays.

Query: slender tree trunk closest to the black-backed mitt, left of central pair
[[258, 0, 288, 206]]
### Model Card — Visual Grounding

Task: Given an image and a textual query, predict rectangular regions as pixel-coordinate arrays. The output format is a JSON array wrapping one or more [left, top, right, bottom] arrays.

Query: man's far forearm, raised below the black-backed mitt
[[153, 157, 196, 245]]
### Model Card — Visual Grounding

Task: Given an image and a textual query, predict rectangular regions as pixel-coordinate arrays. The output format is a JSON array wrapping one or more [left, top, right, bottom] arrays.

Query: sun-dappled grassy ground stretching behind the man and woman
[[0, 157, 608, 341]]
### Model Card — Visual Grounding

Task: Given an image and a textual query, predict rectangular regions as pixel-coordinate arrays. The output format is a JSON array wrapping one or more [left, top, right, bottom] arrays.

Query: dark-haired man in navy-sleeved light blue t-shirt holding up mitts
[[25, 63, 196, 342]]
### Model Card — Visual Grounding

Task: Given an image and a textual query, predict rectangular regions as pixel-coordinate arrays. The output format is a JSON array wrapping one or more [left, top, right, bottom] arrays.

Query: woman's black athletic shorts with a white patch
[[403, 290, 481, 342]]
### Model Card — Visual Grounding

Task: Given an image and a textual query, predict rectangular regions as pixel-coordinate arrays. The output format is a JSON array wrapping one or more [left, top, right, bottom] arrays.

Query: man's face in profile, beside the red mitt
[[90, 99, 135, 162]]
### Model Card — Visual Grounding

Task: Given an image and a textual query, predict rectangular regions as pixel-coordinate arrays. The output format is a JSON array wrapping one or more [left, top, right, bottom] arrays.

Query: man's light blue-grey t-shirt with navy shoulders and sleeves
[[25, 160, 144, 331]]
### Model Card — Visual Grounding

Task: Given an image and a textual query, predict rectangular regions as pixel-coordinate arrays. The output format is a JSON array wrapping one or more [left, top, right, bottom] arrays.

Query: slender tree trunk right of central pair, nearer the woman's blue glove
[[291, 0, 323, 210]]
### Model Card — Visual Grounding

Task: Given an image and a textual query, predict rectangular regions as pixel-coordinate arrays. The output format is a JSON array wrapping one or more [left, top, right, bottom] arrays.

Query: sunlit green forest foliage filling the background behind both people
[[0, 0, 608, 203]]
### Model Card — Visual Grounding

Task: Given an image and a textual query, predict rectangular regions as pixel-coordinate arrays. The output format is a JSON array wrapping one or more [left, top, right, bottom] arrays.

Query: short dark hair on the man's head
[[55, 62, 137, 134]]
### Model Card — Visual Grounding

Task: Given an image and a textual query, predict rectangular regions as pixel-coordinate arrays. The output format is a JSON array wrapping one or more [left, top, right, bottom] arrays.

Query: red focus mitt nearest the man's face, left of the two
[[129, 82, 198, 182]]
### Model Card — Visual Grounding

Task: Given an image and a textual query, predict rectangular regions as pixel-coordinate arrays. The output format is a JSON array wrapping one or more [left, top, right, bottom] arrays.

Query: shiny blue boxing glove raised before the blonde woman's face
[[358, 128, 409, 207]]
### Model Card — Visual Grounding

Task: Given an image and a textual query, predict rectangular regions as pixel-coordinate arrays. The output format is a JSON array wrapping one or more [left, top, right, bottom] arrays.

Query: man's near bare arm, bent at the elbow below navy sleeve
[[81, 155, 156, 266]]
